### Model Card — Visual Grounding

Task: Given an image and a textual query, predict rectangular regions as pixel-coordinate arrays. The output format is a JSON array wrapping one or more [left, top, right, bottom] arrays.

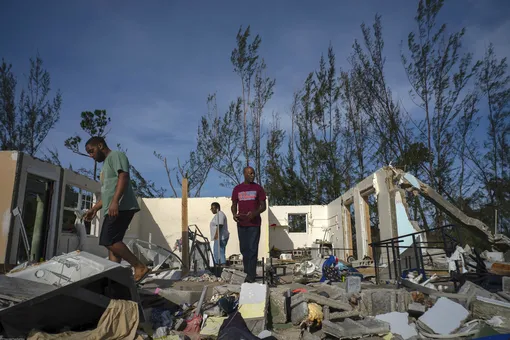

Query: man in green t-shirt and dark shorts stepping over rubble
[[85, 137, 149, 283]]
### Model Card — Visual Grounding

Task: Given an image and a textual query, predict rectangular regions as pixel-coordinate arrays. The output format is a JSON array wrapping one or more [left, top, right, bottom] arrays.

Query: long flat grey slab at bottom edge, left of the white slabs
[[322, 318, 390, 339]]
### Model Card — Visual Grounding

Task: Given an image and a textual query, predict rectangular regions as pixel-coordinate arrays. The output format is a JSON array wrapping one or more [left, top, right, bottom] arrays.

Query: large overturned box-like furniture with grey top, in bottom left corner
[[0, 252, 144, 337]]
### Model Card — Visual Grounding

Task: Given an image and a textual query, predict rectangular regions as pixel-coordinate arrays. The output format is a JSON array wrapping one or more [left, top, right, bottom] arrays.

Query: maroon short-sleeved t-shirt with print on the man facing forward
[[232, 183, 266, 227]]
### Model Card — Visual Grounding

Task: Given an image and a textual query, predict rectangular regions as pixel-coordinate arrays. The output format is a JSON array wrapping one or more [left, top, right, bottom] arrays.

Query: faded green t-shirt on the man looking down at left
[[99, 151, 140, 216]]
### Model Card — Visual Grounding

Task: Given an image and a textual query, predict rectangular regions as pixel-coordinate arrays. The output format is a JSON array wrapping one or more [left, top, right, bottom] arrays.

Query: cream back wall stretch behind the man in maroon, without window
[[127, 197, 269, 258]]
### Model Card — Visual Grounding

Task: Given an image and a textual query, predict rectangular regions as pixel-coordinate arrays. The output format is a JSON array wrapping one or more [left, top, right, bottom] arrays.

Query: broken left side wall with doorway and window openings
[[0, 151, 106, 270]]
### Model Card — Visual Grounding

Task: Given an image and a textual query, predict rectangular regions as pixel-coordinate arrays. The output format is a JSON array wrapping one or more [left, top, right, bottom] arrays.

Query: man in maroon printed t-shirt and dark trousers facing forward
[[232, 166, 266, 282]]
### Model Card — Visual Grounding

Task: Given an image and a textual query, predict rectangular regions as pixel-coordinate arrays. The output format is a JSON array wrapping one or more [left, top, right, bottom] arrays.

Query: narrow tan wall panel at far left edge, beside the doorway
[[0, 151, 18, 263]]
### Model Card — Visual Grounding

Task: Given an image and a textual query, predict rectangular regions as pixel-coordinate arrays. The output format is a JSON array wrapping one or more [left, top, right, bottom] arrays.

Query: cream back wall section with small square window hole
[[269, 205, 329, 250]]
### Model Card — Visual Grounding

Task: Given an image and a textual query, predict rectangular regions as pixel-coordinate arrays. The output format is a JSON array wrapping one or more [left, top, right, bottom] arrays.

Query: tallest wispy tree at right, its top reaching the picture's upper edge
[[402, 0, 479, 199]]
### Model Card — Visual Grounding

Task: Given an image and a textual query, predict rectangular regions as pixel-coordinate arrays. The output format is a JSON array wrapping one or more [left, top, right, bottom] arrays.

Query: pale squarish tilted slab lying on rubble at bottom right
[[418, 297, 469, 335]]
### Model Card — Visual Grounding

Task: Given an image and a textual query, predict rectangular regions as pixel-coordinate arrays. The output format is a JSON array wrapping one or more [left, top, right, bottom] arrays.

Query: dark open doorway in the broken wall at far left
[[17, 174, 55, 264]]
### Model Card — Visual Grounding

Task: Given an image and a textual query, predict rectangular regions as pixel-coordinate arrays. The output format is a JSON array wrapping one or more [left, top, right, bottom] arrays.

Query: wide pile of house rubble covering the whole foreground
[[0, 247, 510, 340]]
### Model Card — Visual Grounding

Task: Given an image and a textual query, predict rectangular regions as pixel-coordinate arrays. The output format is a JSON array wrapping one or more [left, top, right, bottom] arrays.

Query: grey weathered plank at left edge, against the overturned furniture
[[0, 275, 57, 301]]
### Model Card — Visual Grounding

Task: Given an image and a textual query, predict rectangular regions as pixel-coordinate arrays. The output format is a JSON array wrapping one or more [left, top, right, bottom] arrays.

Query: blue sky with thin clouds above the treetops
[[0, 0, 510, 196]]
